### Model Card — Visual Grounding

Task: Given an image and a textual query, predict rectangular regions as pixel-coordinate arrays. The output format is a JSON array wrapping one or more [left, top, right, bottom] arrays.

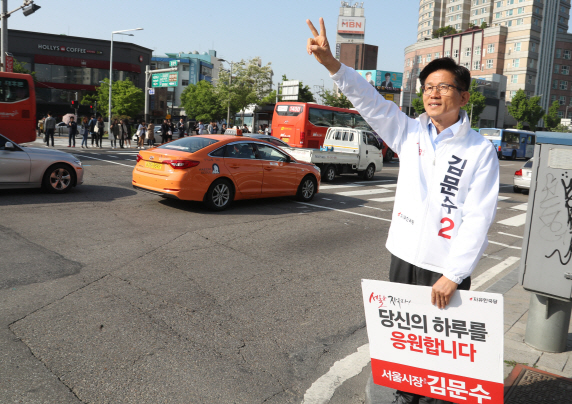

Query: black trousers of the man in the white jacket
[[389, 254, 471, 404]]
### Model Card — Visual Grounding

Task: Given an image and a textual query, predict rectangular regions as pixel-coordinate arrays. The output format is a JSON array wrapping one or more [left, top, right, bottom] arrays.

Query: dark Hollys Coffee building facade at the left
[[8, 30, 152, 118]]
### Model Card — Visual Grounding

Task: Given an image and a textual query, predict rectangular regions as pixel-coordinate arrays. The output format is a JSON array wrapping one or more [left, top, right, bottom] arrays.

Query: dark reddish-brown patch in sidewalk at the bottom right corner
[[504, 365, 572, 404]]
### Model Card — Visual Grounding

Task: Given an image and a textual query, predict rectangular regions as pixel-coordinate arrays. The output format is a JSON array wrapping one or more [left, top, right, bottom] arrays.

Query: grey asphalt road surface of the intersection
[[0, 147, 528, 404]]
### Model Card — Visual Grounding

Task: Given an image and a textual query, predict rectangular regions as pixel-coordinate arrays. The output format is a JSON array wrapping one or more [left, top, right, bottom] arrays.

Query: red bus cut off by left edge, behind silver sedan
[[0, 72, 36, 143]]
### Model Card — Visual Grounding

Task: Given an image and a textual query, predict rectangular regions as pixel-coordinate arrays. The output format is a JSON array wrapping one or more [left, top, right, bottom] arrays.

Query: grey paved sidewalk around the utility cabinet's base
[[366, 265, 572, 404]]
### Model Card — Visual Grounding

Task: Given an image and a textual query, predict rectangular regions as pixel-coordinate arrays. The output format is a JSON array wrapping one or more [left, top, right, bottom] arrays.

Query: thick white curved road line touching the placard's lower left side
[[302, 344, 371, 404]]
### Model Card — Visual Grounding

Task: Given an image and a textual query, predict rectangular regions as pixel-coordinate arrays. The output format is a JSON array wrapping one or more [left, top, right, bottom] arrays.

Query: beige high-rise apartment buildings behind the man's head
[[404, 0, 572, 126]]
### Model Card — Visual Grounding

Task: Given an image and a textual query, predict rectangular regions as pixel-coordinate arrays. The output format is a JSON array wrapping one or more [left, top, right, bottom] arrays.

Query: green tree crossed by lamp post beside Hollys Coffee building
[[80, 79, 145, 118]]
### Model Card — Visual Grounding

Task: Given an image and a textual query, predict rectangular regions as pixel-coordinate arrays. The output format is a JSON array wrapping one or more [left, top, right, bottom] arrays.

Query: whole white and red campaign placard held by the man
[[362, 279, 504, 404]]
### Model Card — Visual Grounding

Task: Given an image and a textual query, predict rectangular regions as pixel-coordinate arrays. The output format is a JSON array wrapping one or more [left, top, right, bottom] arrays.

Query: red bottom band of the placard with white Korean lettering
[[371, 359, 504, 404]]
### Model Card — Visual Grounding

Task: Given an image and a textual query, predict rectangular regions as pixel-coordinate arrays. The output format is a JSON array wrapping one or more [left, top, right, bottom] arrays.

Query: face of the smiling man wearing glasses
[[423, 70, 470, 122]]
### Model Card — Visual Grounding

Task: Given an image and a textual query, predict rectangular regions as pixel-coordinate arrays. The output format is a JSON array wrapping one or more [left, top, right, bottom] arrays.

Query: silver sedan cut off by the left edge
[[0, 135, 83, 194]]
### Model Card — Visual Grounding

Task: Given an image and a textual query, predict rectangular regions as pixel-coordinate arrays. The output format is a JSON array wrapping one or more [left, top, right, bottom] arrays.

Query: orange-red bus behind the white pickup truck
[[272, 101, 394, 161]]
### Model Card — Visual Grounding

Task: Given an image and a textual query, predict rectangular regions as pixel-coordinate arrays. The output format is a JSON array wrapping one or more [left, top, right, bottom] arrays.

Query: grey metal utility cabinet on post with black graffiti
[[520, 132, 572, 352]]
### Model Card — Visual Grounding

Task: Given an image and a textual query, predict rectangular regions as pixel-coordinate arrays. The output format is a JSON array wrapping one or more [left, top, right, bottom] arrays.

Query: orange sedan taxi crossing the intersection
[[133, 135, 320, 210]]
